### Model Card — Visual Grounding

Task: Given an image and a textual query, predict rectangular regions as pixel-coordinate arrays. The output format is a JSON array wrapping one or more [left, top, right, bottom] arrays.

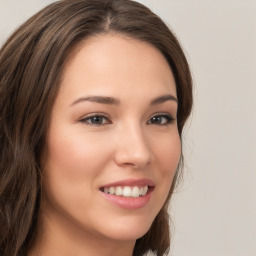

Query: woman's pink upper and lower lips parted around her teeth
[[100, 179, 155, 210]]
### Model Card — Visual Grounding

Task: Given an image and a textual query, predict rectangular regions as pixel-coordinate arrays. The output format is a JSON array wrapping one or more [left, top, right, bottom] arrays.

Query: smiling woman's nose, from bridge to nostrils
[[115, 125, 154, 169]]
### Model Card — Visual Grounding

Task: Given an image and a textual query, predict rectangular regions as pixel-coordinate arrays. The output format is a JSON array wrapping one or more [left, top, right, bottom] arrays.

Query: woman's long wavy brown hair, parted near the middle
[[0, 0, 192, 256]]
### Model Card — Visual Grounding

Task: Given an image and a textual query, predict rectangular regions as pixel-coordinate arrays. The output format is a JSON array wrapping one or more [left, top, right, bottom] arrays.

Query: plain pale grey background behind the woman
[[0, 0, 256, 256]]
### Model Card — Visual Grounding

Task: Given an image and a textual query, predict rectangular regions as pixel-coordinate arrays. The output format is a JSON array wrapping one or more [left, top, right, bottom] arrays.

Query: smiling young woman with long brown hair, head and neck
[[0, 0, 192, 256]]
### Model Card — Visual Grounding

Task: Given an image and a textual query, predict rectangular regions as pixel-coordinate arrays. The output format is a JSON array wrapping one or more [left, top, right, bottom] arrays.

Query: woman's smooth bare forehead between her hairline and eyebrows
[[57, 34, 176, 102]]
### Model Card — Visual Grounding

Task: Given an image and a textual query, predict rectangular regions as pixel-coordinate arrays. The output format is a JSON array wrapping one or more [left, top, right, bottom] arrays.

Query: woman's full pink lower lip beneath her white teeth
[[100, 191, 152, 210]]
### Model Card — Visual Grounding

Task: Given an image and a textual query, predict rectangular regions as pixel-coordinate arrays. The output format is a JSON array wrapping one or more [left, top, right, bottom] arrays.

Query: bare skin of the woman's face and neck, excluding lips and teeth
[[29, 34, 181, 256]]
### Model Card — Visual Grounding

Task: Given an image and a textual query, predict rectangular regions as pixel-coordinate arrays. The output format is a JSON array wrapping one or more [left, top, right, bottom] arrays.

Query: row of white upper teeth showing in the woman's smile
[[103, 186, 148, 197]]
